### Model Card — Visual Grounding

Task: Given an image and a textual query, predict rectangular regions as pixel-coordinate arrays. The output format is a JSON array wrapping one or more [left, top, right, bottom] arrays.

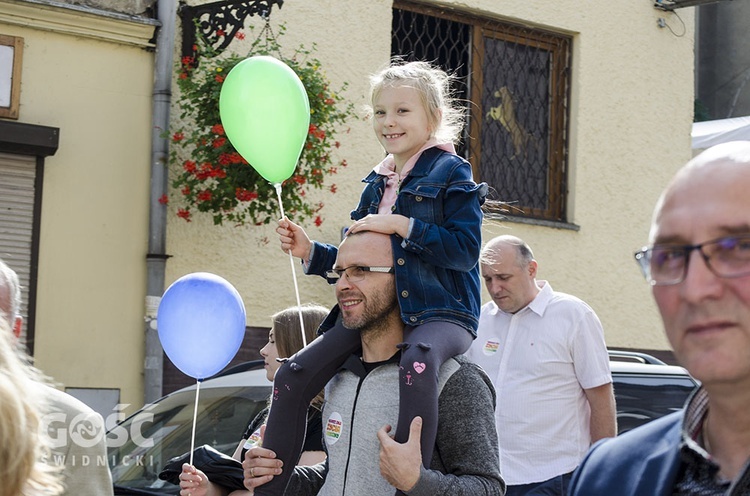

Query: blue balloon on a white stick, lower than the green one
[[157, 272, 246, 380]]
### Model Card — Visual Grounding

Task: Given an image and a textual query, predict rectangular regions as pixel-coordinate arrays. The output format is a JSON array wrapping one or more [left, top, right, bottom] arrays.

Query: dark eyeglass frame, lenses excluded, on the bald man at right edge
[[634, 233, 750, 286]]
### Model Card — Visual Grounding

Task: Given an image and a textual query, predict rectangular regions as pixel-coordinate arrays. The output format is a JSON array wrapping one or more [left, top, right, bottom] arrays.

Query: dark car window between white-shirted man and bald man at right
[[612, 373, 696, 434]]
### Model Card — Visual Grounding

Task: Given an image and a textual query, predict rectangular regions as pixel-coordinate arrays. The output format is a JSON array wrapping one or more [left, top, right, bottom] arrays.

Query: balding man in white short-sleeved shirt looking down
[[466, 236, 617, 496]]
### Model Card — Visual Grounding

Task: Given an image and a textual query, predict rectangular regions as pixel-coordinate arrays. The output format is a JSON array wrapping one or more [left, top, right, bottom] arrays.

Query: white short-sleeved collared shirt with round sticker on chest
[[466, 281, 612, 485]]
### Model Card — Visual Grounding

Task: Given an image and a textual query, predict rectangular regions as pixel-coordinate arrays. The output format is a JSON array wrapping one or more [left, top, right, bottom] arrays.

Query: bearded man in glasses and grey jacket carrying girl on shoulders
[[243, 232, 505, 496]]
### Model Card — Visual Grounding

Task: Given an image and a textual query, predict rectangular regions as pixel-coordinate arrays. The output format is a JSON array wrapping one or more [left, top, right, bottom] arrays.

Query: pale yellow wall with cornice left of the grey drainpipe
[[0, 0, 155, 406]]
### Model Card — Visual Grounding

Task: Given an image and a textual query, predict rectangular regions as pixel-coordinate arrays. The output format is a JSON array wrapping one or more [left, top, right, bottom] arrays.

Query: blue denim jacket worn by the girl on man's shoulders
[[307, 148, 487, 337]]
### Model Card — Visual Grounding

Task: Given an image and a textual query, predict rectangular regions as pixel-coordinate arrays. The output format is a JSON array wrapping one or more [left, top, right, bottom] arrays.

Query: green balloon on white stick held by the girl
[[219, 55, 310, 184]]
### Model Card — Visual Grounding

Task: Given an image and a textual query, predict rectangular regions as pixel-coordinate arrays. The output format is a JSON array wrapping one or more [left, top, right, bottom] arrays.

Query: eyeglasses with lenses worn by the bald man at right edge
[[635, 234, 750, 286]]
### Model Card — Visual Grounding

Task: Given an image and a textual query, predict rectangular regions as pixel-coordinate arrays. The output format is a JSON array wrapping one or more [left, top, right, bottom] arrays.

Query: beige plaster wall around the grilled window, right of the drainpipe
[[167, 0, 693, 356]]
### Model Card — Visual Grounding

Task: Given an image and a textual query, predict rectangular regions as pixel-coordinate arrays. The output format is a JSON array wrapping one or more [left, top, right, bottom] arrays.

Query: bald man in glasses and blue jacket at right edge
[[570, 141, 750, 496]]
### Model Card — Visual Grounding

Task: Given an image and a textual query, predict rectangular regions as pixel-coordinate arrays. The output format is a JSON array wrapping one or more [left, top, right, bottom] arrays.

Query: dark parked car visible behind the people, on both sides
[[107, 351, 697, 495]]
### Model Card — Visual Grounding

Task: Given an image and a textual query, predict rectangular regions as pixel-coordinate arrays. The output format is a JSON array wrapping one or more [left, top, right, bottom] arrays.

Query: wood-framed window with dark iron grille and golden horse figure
[[391, 0, 571, 222]]
